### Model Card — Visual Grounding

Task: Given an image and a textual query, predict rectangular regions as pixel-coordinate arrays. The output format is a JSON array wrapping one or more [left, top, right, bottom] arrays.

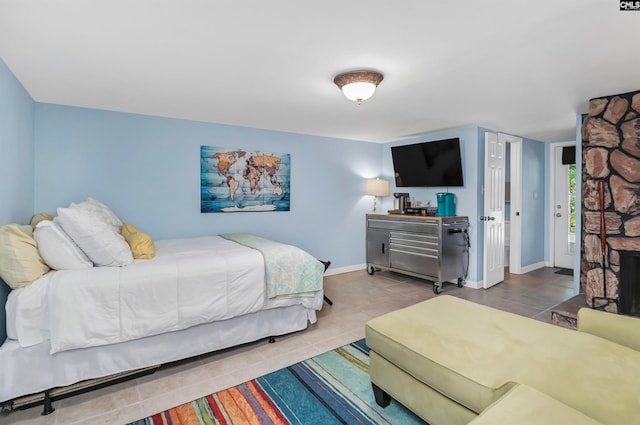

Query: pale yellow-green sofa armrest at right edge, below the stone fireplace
[[578, 308, 640, 351]]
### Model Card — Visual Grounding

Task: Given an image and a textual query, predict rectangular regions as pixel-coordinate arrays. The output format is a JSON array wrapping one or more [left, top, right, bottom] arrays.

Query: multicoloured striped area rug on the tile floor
[[130, 340, 425, 425]]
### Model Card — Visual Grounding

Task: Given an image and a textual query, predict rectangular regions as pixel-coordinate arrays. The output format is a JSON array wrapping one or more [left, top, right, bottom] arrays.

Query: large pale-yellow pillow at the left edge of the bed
[[0, 224, 49, 289]]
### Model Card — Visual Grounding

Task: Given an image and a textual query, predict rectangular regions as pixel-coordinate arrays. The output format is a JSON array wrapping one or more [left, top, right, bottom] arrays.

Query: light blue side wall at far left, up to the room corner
[[0, 59, 34, 344]]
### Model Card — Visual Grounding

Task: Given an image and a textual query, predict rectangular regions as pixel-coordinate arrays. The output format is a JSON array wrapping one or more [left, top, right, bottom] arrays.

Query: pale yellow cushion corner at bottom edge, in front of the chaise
[[469, 385, 600, 425]]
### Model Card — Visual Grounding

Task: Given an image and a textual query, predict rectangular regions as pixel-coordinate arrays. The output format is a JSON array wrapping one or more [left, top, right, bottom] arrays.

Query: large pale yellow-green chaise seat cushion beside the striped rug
[[366, 295, 640, 424]]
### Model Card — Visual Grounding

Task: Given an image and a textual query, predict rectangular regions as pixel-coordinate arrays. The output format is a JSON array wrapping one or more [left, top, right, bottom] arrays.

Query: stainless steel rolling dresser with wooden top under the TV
[[367, 214, 469, 294]]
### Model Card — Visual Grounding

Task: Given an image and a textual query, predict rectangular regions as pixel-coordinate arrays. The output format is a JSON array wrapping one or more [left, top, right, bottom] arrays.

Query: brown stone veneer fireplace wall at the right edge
[[580, 91, 640, 313]]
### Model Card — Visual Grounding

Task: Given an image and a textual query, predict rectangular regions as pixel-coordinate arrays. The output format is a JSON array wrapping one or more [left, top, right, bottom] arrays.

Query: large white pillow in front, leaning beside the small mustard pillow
[[53, 207, 133, 266]]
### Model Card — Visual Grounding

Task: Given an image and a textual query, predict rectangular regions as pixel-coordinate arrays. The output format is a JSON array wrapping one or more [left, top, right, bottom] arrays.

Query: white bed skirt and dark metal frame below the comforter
[[0, 240, 333, 415]]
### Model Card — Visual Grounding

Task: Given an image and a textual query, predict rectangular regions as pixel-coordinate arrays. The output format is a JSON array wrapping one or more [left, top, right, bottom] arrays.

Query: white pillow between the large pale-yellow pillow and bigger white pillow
[[33, 220, 93, 270]]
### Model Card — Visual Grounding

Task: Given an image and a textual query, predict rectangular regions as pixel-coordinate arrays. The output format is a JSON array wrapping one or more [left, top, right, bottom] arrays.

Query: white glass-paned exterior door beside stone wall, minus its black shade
[[553, 146, 576, 269]]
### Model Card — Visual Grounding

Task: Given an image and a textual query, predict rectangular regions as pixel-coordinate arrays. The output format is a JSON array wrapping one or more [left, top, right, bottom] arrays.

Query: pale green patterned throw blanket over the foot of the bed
[[220, 233, 324, 298]]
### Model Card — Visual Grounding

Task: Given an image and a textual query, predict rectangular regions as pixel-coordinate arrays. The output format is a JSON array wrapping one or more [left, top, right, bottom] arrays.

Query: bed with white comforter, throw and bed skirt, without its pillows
[[0, 198, 324, 411]]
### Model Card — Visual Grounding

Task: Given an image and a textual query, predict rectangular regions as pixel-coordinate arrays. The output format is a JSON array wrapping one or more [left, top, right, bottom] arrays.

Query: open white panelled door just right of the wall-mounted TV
[[480, 132, 505, 288]]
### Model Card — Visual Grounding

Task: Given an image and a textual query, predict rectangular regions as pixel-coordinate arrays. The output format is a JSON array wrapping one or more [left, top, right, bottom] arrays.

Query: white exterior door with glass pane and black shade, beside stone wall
[[550, 143, 576, 269]]
